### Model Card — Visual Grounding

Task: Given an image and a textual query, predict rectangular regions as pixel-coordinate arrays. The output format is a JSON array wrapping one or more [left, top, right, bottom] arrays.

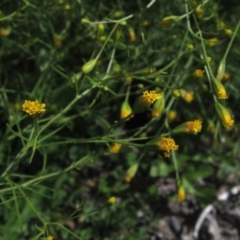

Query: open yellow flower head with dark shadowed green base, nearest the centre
[[133, 91, 162, 113]]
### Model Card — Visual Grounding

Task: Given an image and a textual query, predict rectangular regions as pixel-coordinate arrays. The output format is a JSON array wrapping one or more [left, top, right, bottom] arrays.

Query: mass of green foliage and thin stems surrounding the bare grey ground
[[0, 0, 240, 240]]
